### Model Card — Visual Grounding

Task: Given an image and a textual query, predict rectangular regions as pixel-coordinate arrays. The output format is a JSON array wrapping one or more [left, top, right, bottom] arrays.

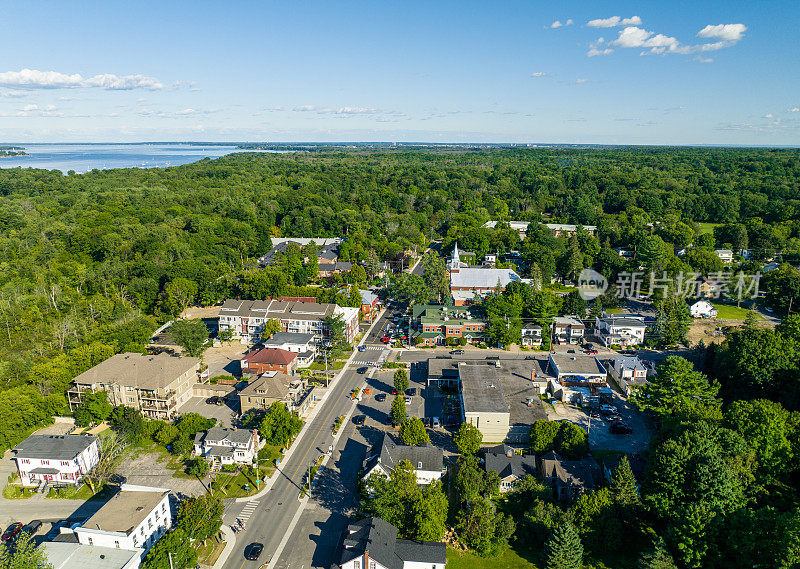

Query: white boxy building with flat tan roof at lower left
[[75, 484, 172, 555]]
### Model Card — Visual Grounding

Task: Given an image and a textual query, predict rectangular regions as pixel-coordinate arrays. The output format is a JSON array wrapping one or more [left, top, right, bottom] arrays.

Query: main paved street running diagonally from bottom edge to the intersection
[[224, 349, 382, 569]]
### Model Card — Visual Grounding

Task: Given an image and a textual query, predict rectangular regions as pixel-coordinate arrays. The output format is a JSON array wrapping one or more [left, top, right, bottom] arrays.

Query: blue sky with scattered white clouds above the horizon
[[0, 0, 800, 145]]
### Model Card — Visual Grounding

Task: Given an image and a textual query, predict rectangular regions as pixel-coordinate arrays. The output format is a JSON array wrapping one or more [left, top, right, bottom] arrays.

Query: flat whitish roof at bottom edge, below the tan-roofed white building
[[39, 541, 143, 569]]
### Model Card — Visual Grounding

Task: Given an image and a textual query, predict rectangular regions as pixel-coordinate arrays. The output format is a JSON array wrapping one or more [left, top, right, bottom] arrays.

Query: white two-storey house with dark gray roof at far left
[[11, 435, 100, 486]]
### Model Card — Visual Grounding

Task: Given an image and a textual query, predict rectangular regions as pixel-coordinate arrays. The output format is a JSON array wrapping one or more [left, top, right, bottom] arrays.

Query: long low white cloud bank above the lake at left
[[0, 69, 164, 91]]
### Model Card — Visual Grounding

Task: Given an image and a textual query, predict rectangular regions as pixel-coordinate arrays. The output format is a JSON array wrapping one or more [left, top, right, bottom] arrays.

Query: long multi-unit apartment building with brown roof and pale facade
[[219, 300, 359, 344]]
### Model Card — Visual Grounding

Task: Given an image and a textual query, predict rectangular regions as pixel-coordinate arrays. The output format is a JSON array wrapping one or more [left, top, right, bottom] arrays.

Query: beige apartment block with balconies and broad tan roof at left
[[67, 352, 200, 419]]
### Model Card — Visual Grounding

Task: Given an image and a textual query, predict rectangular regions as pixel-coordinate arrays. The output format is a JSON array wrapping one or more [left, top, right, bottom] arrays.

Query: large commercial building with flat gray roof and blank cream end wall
[[458, 362, 511, 442]]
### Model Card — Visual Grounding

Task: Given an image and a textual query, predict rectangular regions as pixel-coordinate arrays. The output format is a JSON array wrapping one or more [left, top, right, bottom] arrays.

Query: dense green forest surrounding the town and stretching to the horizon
[[0, 148, 800, 567]]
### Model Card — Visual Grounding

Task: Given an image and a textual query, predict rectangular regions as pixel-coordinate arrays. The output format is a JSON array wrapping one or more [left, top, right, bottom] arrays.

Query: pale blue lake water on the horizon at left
[[0, 143, 274, 173]]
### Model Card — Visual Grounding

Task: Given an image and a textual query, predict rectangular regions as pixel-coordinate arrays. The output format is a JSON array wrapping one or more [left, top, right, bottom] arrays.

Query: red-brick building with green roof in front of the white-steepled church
[[411, 305, 486, 346]]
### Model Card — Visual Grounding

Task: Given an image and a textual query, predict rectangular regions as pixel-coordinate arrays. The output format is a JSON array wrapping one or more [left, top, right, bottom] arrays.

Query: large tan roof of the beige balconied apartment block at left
[[74, 352, 200, 390]]
